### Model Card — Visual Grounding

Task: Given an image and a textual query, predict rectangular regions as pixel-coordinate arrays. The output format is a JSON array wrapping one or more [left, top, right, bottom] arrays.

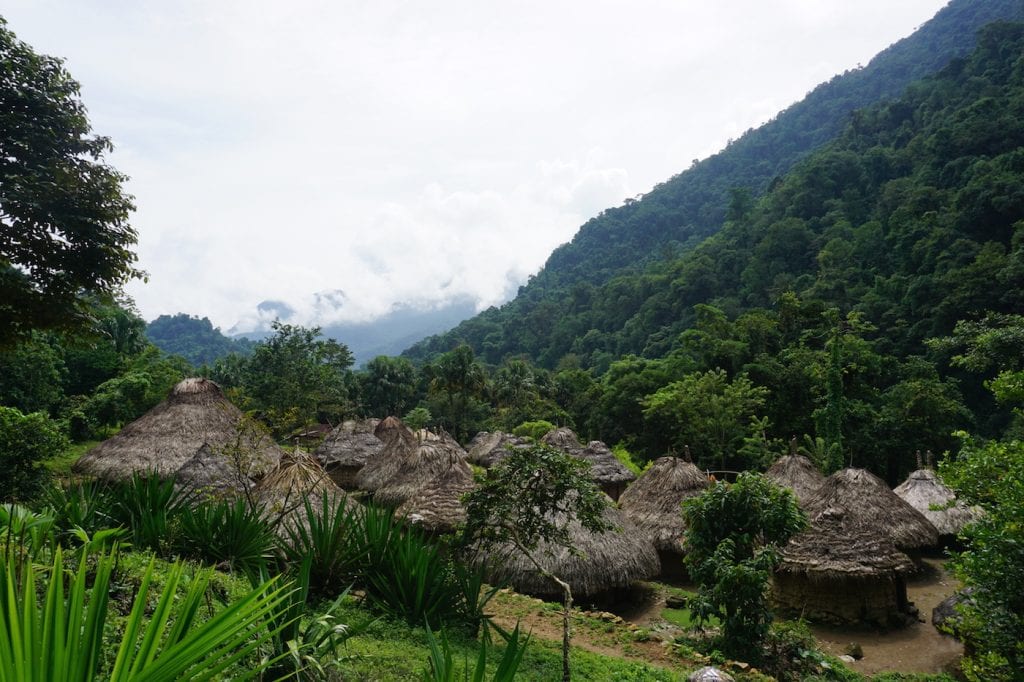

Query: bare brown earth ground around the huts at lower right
[[492, 558, 964, 675]]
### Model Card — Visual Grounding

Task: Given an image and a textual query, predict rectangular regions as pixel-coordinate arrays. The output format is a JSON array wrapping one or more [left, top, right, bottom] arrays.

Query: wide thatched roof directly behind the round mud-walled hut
[[804, 468, 939, 549]]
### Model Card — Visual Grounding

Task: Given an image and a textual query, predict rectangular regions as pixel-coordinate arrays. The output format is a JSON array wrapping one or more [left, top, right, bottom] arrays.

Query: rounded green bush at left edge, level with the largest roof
[[0, 408, 69, 501]]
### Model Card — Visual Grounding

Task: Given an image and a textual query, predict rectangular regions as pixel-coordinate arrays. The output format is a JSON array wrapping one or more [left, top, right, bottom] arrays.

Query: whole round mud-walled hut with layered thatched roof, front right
[[772, 501, 913, 627]]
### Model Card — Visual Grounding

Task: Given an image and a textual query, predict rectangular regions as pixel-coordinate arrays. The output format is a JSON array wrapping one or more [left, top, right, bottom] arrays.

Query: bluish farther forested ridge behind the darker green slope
[[407, 0, 1024, 367]]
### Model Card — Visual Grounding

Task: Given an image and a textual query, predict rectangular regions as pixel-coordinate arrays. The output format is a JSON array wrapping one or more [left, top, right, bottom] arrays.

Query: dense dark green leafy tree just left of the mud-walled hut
[[683, 472, 807, 663]]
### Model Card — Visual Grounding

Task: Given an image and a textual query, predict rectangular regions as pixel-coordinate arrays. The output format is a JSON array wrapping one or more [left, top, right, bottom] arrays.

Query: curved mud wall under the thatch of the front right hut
[[772, 572, 907, 627]]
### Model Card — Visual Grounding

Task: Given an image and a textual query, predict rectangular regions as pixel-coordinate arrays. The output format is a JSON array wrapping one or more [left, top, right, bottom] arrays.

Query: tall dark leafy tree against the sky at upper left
[[0, 18, 141, 346]]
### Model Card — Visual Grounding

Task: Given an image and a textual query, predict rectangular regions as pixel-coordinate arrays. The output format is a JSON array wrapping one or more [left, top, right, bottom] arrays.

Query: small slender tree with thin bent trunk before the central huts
[[463, 444, 611, 681]]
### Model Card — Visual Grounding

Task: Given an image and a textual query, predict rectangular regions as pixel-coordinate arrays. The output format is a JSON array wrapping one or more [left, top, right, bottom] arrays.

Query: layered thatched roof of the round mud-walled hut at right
[[778, 507, 913, 581]]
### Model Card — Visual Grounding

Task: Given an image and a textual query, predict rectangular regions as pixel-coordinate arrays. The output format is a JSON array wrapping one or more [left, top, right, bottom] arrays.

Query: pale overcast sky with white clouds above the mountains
[[6, 0, 945, 331]]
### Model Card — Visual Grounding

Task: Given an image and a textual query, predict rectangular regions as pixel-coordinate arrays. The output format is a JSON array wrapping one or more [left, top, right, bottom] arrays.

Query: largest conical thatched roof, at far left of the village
[[73, 378, 282, 480]]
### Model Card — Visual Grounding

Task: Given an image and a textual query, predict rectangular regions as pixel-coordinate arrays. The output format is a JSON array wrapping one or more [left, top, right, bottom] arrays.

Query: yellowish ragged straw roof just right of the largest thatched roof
[[254, 450, 358, 537]]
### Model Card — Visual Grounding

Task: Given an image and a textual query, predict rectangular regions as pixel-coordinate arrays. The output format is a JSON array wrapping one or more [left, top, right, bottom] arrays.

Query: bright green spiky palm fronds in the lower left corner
[[0, 548, 287, 682]]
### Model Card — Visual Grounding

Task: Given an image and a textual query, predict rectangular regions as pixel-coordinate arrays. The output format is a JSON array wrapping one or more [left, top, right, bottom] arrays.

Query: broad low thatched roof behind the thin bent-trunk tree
[[478, 500, 660, 596]]
